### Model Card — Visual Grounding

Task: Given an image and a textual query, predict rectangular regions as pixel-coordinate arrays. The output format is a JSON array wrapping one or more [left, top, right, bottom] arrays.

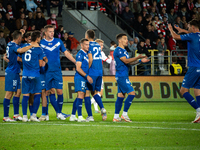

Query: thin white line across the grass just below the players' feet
[[0, 123, 200, 131]]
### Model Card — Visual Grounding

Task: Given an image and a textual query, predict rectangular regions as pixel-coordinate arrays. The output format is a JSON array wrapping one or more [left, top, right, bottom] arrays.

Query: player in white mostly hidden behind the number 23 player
[[91, 39, 112, 113]]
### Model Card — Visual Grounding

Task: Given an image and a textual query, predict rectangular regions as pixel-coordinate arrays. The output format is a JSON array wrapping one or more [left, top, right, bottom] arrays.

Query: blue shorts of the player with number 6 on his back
[[22, 76, 42, 94]]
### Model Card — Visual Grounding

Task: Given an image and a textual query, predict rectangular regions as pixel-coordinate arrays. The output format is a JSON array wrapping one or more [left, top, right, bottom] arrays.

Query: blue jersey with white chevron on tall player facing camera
[[40, 38, 66, 71]]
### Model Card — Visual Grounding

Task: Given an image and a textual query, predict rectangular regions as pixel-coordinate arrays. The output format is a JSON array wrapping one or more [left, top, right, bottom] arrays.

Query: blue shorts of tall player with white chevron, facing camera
[[46, 71, 63, 90]]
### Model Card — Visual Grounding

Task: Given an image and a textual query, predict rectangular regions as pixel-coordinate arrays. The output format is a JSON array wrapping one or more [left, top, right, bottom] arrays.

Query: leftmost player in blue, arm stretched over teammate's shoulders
[[3, 30, 38, 122]]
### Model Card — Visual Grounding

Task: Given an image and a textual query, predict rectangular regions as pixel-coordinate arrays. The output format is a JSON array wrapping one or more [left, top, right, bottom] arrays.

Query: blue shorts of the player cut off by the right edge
[[182, 67, 200, 89]]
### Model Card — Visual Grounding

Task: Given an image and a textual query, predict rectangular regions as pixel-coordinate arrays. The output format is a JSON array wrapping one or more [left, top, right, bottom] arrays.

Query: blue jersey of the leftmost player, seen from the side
[[6, 41, 20, 73]]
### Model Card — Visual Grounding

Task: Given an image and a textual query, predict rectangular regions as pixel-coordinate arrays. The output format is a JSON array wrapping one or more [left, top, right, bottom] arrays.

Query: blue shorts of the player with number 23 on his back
[[87, 76, 102, 92]]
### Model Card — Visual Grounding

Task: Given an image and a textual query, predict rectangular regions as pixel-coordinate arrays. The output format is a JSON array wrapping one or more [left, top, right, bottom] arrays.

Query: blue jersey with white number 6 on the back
[[21, 44, 44, 77]]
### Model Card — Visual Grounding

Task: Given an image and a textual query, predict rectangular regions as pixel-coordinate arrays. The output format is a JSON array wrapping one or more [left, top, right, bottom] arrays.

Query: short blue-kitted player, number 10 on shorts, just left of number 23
[[69, 39, 94, 122]]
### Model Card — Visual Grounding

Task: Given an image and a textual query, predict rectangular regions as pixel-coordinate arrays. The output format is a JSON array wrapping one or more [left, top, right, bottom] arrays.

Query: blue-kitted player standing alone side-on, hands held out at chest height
[[113, 33, 149, 122]]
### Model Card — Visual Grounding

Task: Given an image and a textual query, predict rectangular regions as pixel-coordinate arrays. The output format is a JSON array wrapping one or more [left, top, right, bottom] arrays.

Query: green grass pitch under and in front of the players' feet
[[0, 102, 200, 150]]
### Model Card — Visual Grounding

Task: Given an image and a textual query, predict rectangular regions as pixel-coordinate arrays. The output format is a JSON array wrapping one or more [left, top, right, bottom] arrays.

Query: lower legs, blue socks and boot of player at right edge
[[180, 87, 200, 123]]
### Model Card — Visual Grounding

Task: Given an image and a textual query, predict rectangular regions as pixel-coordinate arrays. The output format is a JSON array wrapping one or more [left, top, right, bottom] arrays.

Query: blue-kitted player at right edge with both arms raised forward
[[169, 20, 200, 123]]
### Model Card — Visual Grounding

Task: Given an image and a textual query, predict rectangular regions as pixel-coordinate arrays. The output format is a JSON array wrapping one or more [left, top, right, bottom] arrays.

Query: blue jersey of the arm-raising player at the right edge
[[180, 33, 200, 67]]
